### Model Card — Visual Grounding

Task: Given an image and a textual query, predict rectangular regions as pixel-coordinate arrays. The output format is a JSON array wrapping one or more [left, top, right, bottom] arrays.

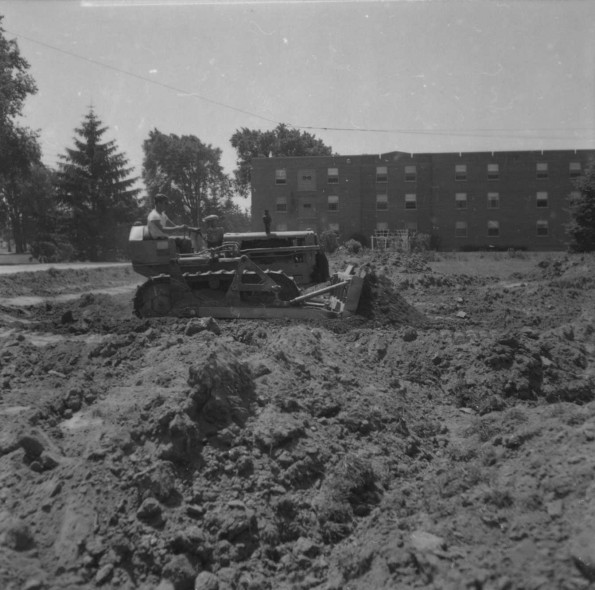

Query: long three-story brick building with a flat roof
[[252, 150, 595, 250]]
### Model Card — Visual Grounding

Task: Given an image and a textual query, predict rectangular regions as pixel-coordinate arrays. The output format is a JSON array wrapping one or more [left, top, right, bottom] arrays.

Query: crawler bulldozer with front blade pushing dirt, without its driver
[[128, 225, 365, 319]]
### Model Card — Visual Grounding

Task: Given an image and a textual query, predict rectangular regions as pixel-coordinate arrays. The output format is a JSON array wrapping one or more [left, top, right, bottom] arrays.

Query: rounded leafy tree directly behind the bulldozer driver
[[143, 129, 231, 226]]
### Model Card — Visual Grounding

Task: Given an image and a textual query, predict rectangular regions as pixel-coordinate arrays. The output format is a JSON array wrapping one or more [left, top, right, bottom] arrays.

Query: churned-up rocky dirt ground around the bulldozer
[[0, 253, 595, 590]]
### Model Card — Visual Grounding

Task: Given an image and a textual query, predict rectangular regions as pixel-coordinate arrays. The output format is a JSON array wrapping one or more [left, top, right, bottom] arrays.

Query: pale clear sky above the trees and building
[[0, 0, 595, 206]]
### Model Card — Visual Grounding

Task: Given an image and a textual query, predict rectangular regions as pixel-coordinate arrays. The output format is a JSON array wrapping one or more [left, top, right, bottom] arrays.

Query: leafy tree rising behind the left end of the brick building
[[230, 123, 332, 197]]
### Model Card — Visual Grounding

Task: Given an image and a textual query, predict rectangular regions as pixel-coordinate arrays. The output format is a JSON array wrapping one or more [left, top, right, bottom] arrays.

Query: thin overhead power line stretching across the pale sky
[[5, 29, 595, 141]]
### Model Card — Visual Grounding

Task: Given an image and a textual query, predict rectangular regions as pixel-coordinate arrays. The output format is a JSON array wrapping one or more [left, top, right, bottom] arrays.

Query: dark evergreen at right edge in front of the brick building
[[566, 161, 595, 252]]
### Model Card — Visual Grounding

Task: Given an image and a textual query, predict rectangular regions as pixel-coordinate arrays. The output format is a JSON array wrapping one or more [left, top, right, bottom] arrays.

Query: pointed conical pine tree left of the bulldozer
[[58, 108, 140, 260]]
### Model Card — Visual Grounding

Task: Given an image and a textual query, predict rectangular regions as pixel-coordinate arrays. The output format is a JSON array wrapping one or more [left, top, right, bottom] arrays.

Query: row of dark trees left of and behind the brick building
[[0, 15, 331, 261]]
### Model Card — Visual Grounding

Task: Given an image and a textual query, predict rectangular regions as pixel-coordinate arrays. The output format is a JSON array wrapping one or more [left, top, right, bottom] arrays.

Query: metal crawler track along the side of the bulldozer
[[133, 270, 300, 318]]
